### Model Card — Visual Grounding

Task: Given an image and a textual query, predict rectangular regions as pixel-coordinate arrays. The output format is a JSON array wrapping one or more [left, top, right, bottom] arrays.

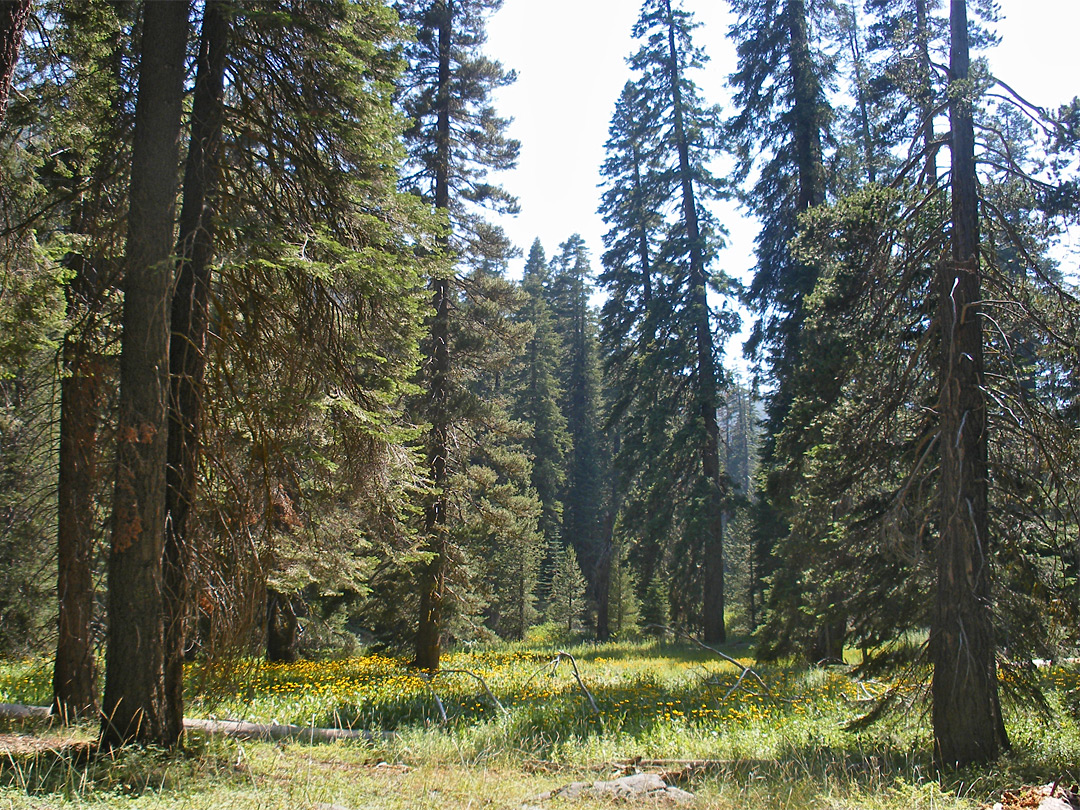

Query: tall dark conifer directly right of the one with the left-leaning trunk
[[730, 0, 846, 660]]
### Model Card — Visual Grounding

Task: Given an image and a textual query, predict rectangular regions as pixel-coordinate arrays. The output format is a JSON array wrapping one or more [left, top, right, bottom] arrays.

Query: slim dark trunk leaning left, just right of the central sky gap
[[664, 0, 727, 644]]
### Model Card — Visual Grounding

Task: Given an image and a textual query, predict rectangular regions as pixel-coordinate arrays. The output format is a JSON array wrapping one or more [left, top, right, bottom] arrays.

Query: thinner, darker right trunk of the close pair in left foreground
[[164, 0, 229, 747]]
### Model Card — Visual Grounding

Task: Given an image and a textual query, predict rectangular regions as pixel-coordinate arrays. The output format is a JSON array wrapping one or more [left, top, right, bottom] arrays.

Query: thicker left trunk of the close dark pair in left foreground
[[102, 2, 188, 747]]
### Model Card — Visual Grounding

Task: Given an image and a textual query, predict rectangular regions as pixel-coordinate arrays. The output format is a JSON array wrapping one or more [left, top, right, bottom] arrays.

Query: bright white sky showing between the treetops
[[487, 0, 1080, 293]]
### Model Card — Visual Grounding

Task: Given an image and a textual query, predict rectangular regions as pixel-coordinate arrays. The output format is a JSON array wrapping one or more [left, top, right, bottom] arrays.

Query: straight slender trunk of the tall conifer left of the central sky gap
[[413, 0, 454, 672]]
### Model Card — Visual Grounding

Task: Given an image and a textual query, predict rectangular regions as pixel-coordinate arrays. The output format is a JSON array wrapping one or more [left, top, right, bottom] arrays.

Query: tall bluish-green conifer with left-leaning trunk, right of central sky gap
[[600, 0, 733, 640]]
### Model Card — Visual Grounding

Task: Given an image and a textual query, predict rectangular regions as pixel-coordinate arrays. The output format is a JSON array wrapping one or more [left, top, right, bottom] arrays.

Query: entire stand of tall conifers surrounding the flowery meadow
[[0, 0, 1080, 766]]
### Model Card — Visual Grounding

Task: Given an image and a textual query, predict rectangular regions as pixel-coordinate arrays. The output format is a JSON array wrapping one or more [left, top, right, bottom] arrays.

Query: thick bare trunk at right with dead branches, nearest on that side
[[930, 0, 1009, 765]]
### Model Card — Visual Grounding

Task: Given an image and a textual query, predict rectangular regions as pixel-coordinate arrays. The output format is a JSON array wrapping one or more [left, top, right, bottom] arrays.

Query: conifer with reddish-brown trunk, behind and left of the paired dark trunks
[[20, 0, 134, 721]]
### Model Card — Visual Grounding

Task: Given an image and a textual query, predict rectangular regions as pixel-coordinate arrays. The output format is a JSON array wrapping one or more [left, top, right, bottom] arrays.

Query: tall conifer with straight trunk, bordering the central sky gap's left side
[[400, 0, 518, 671]]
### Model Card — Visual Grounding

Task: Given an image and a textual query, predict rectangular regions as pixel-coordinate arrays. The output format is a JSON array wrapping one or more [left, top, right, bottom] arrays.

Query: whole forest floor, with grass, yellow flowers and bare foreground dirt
[[0, 642, 1080, 810]]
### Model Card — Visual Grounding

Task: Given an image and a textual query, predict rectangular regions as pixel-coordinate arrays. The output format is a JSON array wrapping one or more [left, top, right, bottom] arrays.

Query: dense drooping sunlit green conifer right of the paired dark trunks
[[204, 0, 434, 657]]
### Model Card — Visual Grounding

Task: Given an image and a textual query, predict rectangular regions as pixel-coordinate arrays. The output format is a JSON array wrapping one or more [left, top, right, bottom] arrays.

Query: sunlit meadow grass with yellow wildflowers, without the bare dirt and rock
[[0, 642, 1080, 808]]
